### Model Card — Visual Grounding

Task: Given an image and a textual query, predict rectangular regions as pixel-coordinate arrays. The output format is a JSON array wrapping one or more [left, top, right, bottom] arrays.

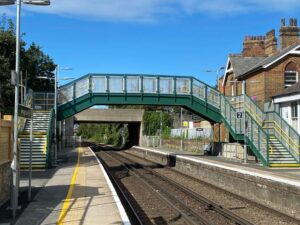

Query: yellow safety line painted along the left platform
[[57, 148, 81, 225]]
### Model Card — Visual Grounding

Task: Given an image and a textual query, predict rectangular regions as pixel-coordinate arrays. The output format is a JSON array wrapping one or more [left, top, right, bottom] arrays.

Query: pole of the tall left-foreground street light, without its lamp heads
[[12, 0, 21, 218]]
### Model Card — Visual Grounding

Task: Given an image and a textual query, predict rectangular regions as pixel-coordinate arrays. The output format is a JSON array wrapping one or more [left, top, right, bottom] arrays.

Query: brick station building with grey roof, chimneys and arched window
[[218, 19, 300, 107]]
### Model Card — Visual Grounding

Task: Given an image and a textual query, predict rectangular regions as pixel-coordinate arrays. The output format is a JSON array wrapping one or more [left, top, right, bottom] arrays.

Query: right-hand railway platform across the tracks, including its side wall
[[128, 146, 300, 220]]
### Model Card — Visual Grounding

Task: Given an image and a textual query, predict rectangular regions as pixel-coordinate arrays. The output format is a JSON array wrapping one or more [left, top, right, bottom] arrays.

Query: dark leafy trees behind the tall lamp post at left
[[0, 15, 55, 114]]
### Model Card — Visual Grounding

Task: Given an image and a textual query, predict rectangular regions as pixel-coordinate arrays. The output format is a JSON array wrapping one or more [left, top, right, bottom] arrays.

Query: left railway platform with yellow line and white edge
[[16, 147, 130, 225]]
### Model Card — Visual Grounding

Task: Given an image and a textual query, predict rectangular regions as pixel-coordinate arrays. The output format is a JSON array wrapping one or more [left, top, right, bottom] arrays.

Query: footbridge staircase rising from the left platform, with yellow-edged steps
[[19, 92, 55, 169]]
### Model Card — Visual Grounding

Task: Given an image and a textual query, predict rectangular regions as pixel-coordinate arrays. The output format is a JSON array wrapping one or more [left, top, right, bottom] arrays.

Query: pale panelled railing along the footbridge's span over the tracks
[[59, 74, 220, 109]]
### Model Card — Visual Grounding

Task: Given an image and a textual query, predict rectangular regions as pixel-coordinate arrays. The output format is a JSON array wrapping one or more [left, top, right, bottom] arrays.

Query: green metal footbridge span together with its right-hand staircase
[[57, 74, 300, 167]]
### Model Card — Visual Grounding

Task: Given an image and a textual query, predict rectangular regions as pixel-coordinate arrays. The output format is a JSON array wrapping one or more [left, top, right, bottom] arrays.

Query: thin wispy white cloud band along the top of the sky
[[5, 0, 300, 22]]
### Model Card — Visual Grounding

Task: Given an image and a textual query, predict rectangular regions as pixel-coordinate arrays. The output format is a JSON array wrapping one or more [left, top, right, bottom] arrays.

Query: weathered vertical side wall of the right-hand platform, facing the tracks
[[130, 148, 300, 219]]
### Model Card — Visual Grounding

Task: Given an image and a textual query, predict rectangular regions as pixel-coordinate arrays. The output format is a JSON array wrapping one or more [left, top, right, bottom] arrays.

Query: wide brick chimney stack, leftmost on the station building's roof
[[243, 36, 266, 57]]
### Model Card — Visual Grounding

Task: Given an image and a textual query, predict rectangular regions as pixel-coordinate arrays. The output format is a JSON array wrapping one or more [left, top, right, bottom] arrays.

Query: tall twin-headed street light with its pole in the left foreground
[[0, 0, 50, 218]]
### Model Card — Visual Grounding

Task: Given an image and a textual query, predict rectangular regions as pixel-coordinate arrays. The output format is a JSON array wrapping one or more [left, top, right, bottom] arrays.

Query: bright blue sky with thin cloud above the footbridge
[[0, 0, 300, 85]]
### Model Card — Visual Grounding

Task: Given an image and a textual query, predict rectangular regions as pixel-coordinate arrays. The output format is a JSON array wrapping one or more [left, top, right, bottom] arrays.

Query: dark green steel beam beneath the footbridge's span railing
[[58, 93, 222, 122]]
